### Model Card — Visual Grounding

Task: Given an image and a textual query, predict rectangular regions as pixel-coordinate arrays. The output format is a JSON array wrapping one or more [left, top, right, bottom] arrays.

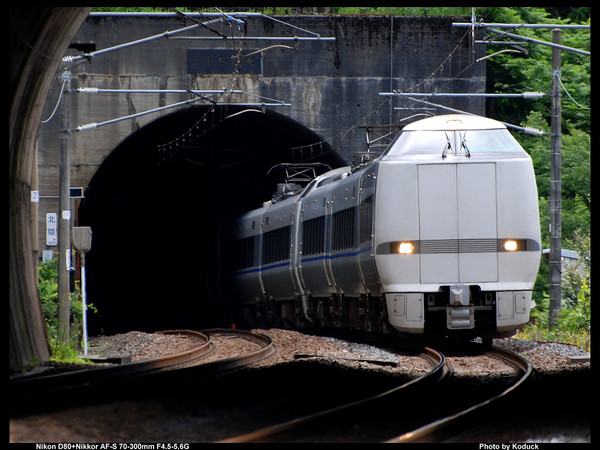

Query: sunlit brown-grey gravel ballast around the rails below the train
[[89, 328, 590, 376]]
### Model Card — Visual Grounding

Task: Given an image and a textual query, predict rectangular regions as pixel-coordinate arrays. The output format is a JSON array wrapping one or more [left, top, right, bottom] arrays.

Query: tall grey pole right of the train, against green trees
[[548, 28, 562, 328]]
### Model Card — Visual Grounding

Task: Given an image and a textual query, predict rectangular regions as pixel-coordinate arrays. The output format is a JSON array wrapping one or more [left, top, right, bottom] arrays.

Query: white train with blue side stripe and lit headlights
[[220, 114, 541, 340]]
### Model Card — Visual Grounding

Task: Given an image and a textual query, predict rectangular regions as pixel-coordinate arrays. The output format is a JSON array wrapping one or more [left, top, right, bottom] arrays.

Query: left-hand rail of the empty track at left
[[9, 330, 214, 398]]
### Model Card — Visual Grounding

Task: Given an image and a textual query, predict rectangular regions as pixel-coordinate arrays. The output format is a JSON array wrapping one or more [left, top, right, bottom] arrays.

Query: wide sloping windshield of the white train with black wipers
[[387, 129, 524, 156]]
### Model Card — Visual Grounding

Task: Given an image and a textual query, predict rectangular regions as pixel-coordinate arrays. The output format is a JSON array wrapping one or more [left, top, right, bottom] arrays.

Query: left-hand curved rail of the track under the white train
[[219, 348, 449, 443]]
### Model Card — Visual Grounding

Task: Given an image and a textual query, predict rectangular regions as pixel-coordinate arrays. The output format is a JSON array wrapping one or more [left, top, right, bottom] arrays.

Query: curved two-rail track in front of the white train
[[219, 347, 532, 443]]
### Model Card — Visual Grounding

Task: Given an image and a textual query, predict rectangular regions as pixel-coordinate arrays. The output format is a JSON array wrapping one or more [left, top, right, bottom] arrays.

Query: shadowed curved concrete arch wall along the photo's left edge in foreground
[[8, 6, 91, 373]]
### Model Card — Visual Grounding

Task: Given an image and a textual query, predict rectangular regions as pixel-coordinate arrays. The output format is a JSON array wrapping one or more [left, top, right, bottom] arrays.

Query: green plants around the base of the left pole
[[38, 258, 94, 363]]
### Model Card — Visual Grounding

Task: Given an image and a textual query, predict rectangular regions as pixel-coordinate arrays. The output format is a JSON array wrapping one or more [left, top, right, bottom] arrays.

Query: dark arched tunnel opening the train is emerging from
[[79, 106, 345, 335]]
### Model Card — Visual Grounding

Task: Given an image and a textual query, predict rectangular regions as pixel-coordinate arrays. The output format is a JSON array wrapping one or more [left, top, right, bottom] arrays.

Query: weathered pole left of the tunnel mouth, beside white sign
[[58, 70, 71, 344]]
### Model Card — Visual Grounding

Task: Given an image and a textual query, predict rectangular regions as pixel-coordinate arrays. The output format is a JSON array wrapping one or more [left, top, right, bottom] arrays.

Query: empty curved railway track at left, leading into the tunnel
[[9, 329, 274, 405]]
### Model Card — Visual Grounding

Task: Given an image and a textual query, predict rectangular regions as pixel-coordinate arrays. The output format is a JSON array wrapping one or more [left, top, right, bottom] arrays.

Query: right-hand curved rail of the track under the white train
[[386, 346, 533, 443]]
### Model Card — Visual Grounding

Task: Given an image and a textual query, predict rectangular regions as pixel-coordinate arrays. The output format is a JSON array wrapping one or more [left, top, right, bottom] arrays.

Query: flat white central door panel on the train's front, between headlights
[[418, 163, 498, 283]]
